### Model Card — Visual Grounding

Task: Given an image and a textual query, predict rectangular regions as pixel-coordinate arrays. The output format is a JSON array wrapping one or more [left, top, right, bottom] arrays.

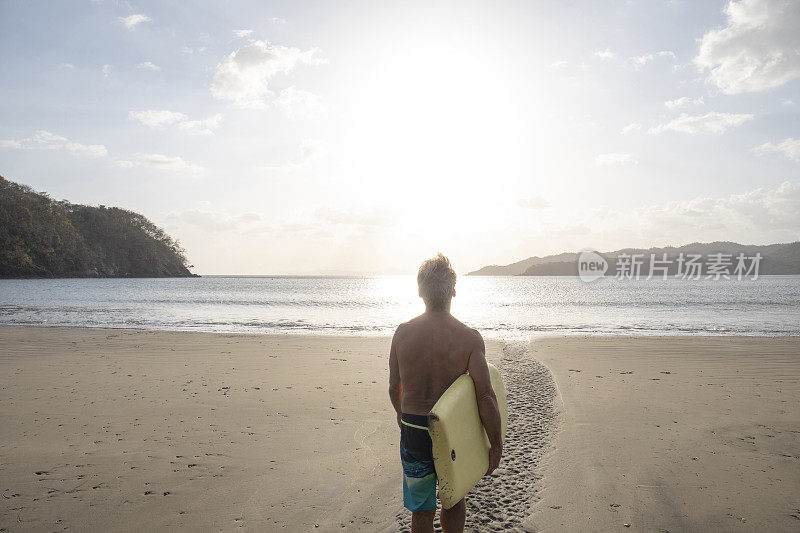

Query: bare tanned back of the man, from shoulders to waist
[[394, 312, 483, 415]]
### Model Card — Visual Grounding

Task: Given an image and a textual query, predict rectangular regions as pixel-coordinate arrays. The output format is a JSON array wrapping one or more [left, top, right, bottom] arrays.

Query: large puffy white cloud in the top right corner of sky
[[694, 0, 800, 94]]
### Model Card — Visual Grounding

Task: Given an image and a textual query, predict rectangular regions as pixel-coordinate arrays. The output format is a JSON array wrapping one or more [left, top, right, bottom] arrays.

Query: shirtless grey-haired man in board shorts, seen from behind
[[389, 254, 503, 533]]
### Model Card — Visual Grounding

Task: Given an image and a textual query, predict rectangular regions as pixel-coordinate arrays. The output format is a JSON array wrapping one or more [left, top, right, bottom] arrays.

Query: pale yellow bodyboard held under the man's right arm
[[428, 364, 508, 509]]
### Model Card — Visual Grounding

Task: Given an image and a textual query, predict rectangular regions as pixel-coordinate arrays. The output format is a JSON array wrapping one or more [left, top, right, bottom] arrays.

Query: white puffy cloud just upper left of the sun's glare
[[211, 41, 325, 108]]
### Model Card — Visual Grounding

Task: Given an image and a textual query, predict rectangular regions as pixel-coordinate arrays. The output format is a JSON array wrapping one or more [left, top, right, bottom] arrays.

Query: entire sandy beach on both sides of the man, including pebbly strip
[[0, 327, 800, 531]]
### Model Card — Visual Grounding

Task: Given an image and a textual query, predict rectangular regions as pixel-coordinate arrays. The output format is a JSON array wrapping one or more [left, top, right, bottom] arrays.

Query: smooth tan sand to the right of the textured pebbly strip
[[526, 337, 800, 531]]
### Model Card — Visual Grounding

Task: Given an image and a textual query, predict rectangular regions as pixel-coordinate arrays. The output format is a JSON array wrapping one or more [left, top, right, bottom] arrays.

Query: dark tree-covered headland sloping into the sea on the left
[[0, 176, 194, 278]]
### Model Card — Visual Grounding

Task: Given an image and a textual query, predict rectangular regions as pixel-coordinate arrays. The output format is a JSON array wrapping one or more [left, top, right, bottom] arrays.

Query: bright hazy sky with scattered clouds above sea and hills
[[0, 0, 800, 275]]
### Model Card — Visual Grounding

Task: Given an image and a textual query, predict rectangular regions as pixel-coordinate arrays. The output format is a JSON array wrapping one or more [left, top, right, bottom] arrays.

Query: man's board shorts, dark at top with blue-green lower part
[[400, 413, 436, 513]]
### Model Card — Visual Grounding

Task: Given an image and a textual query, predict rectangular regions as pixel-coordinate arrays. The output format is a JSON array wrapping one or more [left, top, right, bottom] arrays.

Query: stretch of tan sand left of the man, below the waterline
[[0, 328, 410, 531]]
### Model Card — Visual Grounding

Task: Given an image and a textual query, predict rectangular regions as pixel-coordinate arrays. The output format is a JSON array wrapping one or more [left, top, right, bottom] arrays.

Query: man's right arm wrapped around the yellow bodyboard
[[467, 331, 503, 476]]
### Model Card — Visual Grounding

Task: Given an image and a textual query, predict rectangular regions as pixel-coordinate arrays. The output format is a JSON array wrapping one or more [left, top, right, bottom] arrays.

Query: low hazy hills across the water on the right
[[468, 242, 800, 276]]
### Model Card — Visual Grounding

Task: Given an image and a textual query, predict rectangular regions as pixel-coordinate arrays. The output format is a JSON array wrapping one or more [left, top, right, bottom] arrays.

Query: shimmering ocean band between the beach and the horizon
[[0, 276, 800, 338]]
